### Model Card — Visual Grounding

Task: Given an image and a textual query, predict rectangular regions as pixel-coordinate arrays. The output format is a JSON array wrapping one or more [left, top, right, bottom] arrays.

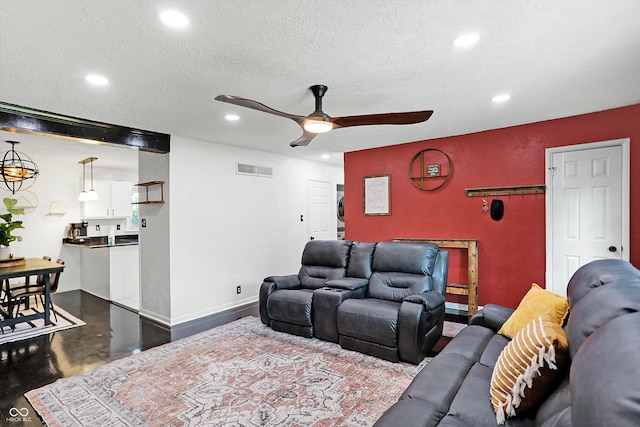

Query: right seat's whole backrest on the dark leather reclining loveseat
[[367, 242, 439, 302]]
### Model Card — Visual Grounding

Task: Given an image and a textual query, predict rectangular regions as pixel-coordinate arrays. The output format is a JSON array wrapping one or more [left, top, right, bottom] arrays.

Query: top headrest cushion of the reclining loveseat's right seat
[[373, 242, 438, 275]]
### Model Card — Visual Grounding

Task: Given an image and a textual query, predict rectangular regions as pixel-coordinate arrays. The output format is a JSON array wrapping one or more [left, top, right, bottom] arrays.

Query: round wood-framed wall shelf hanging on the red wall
[[409, 148, 453, 191]]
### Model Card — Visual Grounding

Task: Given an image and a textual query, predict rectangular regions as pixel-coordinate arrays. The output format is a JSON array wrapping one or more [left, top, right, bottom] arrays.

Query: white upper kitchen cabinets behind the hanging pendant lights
[[83, 180, 133, 219]]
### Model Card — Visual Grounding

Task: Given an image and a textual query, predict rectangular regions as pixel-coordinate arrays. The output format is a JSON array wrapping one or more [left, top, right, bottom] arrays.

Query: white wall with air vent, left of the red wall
[[168, 137, 343, 324]]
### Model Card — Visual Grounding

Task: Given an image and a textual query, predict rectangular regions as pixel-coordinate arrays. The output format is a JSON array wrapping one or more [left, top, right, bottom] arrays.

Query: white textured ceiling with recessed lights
[[0, 0, 640, 166]]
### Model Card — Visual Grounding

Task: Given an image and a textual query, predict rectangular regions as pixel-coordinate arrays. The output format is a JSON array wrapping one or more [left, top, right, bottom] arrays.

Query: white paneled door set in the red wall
[[547, 141, 629, 295]]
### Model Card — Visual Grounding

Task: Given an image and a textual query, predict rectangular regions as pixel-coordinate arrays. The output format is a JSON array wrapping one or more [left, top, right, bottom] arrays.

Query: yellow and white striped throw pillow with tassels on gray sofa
[[490, 313, 569, 425]]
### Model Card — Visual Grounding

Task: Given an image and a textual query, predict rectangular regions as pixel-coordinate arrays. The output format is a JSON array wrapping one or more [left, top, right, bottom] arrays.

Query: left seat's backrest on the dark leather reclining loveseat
[[298, 240, 352, 289]]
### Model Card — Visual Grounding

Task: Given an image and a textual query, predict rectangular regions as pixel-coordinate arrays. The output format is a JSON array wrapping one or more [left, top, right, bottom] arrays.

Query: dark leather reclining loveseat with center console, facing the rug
[[260, 240, 448, 364]]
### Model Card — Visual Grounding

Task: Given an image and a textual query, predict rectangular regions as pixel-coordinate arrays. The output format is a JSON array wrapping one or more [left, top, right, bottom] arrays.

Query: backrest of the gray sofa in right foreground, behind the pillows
[[534, 259, 640, 426]]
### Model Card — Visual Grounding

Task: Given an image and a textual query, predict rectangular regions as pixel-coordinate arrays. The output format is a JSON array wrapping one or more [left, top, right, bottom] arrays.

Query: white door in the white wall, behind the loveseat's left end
[[307, 180, 337, 240]]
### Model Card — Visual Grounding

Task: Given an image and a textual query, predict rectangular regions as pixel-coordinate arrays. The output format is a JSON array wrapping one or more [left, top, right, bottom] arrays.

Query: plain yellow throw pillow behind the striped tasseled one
[[498, 283, 569, 338]]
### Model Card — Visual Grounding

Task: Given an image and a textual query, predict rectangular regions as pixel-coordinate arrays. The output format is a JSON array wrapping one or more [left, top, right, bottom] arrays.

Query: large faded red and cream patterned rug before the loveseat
[[26, 317, 436, 427]]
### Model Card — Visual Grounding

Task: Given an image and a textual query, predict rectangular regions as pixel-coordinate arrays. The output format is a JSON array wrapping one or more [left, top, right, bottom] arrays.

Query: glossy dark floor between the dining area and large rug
[[0, 291, 461, 427]]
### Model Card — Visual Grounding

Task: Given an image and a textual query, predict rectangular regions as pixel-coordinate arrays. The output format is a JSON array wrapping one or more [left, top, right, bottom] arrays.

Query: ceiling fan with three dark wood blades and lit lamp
[[216, 85, 433, 147]]
